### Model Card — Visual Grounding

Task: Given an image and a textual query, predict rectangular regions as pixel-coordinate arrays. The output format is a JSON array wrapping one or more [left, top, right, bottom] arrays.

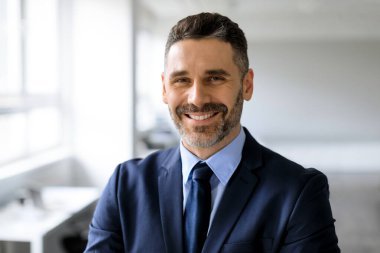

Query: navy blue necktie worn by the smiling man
[[185, 163, 212, 253]]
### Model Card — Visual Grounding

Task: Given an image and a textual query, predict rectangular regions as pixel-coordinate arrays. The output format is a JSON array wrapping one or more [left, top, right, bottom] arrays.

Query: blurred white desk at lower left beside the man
[[0, 187, 99, 253]]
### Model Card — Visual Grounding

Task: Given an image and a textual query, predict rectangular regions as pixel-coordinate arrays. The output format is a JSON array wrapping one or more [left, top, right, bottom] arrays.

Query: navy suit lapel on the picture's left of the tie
[[156, 149, 183, 252]]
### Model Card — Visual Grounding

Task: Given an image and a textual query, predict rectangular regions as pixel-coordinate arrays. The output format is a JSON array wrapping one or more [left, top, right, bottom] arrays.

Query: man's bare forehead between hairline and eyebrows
[[165, 39, 237, 73]]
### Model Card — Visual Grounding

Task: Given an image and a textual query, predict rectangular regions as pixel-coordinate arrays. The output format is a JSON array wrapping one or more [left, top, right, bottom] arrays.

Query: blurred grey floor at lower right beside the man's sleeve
[[327, 173, 380, 253]]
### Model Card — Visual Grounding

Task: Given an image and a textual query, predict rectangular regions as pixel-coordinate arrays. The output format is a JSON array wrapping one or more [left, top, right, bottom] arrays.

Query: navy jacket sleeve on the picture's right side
[[280, 173, 340, 253]]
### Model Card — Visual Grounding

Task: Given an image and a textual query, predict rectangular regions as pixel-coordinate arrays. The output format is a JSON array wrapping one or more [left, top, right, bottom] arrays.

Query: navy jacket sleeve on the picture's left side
[[84, 167, 124, 253]]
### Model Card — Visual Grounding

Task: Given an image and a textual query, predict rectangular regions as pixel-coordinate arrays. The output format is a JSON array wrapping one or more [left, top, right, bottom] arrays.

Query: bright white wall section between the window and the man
[[73, 0, 133, 186]]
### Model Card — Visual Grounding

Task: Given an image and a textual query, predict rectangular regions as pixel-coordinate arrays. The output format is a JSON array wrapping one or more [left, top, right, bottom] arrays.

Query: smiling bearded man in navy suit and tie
[[86, 13, 340, 253]]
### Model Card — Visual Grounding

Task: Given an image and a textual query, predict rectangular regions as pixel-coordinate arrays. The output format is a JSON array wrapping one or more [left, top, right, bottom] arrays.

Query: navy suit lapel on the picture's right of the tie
[[202, 131, 261, 253]]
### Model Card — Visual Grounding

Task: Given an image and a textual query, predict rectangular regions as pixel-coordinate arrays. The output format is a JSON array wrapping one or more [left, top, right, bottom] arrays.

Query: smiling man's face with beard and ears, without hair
[[162, 39, 253, 153]]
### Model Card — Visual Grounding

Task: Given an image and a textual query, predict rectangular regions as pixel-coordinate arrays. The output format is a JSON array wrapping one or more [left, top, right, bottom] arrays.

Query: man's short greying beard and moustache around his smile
[[169, 89, 243, 148]]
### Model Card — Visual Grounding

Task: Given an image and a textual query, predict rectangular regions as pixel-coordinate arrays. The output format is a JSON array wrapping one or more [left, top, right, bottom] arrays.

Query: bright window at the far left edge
[[0, 0, 63, 165]]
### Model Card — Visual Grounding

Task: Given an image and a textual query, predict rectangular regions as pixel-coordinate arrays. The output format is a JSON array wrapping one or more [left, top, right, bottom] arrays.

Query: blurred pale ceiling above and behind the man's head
[[138, 0, 380, 40]]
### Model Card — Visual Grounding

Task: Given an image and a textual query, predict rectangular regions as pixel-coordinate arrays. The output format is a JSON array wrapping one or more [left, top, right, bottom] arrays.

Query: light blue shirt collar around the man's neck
[[180, 128, 245, 186]]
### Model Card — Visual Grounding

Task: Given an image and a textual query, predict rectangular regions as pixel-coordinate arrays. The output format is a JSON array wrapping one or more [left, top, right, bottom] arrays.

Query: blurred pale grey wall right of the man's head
[[243, 40, 380, 170]]
